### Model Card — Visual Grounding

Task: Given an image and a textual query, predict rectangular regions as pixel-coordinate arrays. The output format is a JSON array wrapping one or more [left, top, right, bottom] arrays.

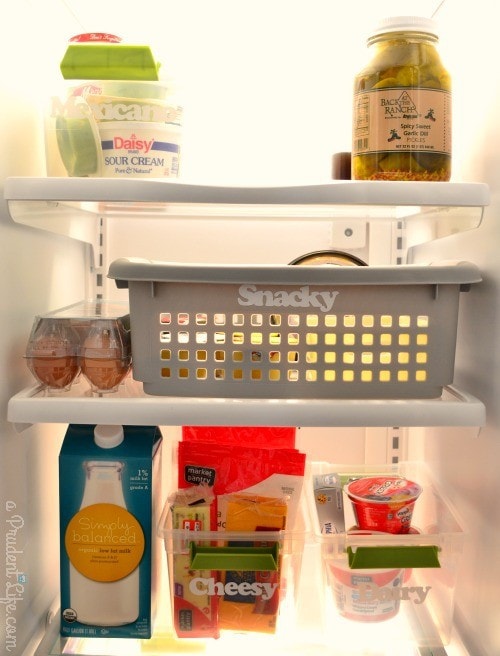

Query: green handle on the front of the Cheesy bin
[[189, 542, 279, 572]]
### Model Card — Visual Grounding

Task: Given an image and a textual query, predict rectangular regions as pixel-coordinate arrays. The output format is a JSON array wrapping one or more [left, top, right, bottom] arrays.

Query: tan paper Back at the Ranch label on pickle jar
[[352, 87, 451, 155]]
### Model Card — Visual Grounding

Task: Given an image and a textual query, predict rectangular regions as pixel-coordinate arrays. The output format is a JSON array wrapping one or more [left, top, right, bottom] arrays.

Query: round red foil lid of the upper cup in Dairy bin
[[345, 476, 422, 504]]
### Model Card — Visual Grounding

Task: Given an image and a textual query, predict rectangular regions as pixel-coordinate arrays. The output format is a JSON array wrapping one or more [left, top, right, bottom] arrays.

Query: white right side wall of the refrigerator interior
[[408, 0, 500, 656]]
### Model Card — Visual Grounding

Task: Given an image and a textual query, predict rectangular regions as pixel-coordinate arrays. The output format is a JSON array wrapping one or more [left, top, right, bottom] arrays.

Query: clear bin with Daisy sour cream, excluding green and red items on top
[[45, 80, 182, 178]]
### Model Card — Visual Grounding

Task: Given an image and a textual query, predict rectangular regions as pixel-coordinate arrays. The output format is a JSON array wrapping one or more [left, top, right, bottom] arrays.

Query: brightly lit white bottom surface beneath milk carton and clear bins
[[34, 560, 464, 656]]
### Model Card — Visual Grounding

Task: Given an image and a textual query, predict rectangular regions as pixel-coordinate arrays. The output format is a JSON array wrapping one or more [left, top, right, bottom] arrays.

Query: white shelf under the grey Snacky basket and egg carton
[[7, 377, 485, 431]]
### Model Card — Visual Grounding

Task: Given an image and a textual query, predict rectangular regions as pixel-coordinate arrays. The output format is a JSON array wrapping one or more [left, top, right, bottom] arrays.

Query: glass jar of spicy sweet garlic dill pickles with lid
[[352, 16, 451, 182]]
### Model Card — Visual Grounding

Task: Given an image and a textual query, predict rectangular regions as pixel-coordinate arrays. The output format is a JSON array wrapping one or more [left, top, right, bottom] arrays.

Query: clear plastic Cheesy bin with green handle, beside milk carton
[[158, 492, 310, 638]]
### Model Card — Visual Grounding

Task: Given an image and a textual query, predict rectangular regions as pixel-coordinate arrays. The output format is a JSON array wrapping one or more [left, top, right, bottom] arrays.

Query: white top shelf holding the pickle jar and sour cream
[[4, 177, 489, 255]]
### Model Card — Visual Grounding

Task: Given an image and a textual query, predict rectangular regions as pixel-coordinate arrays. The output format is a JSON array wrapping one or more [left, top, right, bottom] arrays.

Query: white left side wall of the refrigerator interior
[[0, 1, 89, 656]]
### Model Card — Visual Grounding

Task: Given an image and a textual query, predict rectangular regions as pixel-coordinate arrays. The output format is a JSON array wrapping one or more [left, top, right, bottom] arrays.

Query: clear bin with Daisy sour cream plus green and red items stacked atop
[[45, 32, 183, 178]]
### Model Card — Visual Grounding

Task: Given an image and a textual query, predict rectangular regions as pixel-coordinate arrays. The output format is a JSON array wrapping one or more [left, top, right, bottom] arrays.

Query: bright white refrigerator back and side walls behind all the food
[[0, 0, 500, 656]]
